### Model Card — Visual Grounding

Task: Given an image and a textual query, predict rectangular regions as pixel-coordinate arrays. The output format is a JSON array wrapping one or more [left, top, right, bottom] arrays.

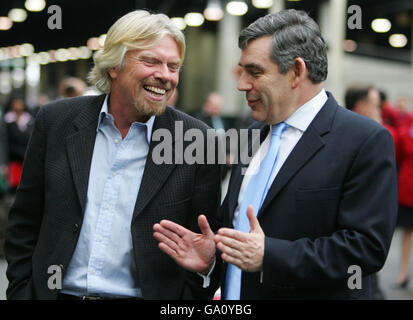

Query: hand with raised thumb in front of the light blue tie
[[214, 206, 265, 272]]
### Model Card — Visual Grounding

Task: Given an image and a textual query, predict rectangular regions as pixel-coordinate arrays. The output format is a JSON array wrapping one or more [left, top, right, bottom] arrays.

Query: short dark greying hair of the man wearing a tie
[[238, 9, 328, 83]]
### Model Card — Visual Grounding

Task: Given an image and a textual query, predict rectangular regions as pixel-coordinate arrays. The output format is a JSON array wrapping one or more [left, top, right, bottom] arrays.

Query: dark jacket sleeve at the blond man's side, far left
[[4, 109, 46, 299]]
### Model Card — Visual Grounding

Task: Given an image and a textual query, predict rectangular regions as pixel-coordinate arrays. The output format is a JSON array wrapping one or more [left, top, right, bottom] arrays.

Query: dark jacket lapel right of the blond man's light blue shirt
[[133, 110, 177, 218]]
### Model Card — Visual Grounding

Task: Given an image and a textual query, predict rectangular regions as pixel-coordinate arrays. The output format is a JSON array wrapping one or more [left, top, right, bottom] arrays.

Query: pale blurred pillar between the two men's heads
[[217, 13, 243, 115]]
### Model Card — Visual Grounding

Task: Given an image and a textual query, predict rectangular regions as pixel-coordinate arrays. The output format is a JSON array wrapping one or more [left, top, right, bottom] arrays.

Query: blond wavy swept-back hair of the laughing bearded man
[[88, 10, 186, 93]]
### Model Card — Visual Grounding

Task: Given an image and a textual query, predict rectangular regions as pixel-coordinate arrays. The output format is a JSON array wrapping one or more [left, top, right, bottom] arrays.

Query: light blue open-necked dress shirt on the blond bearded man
[[61, 96, 155, 297]]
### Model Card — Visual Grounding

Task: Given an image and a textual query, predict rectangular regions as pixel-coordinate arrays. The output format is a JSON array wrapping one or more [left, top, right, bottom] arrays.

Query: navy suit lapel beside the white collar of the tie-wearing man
[[258, 94, 338, 214]]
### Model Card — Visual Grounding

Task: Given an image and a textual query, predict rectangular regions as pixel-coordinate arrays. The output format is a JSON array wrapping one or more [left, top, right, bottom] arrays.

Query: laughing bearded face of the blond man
[[109, 36, 182, 116]]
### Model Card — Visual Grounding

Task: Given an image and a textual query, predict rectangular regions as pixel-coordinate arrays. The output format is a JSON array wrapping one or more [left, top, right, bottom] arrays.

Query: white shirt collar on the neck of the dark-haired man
[[284, 88, 328, 132]]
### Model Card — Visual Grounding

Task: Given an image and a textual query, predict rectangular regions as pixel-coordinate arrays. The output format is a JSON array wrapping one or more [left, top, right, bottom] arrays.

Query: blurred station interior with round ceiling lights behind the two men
[[0, 0, 413, 300]]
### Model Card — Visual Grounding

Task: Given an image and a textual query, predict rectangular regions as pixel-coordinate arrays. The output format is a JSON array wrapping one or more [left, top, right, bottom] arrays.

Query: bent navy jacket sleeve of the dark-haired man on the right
[[263, 128, 397, 288]]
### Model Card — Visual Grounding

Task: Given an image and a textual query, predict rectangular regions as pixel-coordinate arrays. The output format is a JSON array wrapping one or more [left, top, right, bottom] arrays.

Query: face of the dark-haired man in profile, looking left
[[238, 36, 296, 124]]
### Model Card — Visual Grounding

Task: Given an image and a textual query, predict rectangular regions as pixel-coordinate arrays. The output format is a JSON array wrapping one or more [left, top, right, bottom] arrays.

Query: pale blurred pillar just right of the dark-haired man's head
[[319, 0, 347, 105]]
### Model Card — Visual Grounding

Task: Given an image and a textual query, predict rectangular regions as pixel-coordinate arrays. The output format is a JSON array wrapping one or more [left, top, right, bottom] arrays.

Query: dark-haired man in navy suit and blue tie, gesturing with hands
[[154, 10, 397, 300]]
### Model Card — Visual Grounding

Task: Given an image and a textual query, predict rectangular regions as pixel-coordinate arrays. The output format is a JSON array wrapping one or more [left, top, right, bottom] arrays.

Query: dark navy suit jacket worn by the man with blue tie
[[222, 95, 397, 299]]
